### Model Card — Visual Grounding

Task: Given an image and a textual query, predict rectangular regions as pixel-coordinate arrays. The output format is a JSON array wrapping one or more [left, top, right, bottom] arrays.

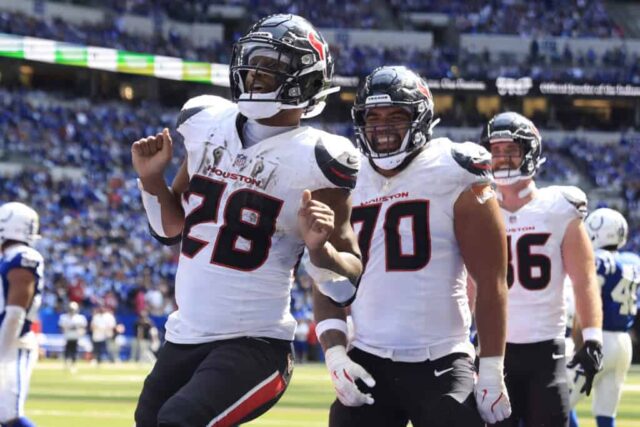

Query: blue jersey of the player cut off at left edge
[[0, 244, 44, 336]]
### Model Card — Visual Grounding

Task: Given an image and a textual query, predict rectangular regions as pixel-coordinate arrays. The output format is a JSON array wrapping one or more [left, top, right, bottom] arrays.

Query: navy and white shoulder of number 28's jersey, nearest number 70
[[314, 135, 360, 190]]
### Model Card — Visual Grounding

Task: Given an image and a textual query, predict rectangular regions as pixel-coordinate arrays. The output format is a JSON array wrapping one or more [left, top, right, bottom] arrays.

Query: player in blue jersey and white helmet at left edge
[[0, 202, 44, 427]]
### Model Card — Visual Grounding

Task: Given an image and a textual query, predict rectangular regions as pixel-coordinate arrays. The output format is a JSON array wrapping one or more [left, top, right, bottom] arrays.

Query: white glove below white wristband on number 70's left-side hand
[[324, 345, 376, 406]]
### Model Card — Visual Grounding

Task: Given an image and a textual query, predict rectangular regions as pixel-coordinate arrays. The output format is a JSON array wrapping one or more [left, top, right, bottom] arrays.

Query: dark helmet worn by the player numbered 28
[[230, 15, 339, 119]]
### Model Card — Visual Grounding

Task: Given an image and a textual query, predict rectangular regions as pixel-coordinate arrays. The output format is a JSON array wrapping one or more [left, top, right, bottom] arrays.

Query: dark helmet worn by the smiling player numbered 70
[[351, 66, 437, 170]]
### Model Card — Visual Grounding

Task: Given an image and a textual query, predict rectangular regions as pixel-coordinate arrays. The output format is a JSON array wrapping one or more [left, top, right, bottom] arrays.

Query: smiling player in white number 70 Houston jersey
[[310, 66, 510, 427]]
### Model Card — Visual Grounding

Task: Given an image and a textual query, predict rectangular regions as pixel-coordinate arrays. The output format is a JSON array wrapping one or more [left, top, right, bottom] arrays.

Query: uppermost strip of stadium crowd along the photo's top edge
[[54, 0, 623, 37]]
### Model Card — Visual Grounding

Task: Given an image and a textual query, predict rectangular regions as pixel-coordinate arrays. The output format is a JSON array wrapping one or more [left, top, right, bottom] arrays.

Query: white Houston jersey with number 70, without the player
[[351, 138, 491, 361]]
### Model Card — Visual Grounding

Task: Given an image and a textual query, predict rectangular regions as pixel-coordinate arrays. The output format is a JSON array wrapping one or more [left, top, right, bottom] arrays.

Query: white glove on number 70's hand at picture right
[[475, 356, 511, 424]]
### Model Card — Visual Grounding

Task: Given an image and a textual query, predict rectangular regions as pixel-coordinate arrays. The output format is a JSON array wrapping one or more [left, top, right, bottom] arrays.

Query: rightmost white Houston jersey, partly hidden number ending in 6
[[502, 186, 587, 343]]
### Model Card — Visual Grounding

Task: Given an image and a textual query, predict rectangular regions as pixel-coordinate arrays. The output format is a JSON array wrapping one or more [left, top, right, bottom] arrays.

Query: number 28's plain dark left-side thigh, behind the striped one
[[135, 342, 212, 427]]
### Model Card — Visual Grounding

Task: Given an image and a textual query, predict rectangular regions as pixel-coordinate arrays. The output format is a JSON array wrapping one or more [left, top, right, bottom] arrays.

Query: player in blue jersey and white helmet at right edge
[[570, 208, 640, 427]]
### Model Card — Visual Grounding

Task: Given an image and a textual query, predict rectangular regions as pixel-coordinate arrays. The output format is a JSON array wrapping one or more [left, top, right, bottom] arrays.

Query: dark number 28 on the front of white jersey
[[181, 175, 283, 271]]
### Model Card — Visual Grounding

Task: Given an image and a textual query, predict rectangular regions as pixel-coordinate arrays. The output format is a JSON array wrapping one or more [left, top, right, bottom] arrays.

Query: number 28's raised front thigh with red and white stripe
[[158, 338, 293, 427]]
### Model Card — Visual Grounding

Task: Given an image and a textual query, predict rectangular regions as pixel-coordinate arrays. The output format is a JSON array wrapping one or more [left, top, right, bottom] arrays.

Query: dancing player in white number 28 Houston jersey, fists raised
[[132, 15, 362, 427]]
